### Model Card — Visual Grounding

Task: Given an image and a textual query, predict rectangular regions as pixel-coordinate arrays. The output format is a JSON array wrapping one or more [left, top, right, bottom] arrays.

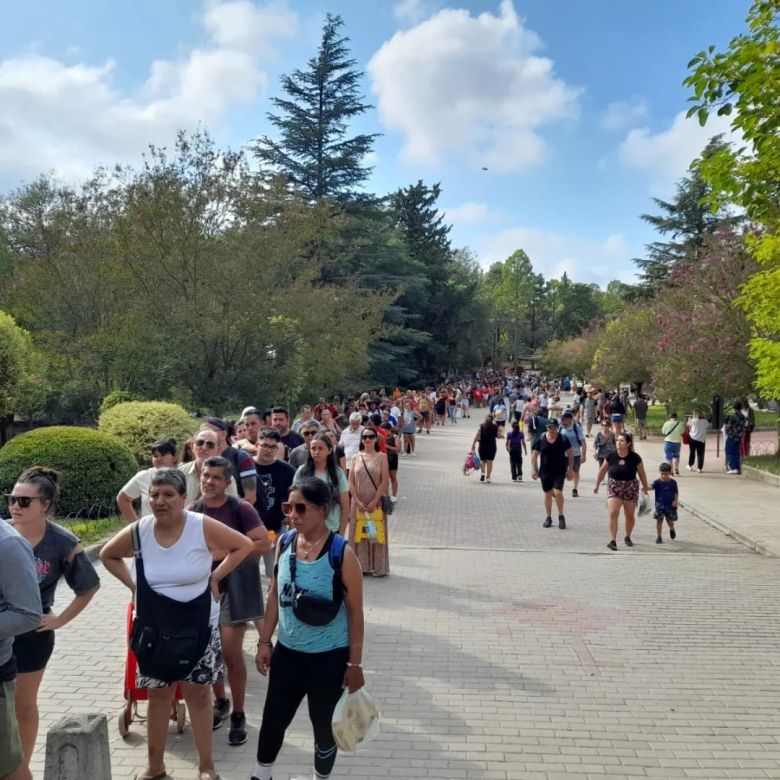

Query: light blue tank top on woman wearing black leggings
[[276, 542, 349, 653]]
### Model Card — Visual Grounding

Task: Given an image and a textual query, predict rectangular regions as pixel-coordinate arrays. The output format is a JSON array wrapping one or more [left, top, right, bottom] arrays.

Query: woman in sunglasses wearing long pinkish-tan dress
[[349, 426, 390, 577]]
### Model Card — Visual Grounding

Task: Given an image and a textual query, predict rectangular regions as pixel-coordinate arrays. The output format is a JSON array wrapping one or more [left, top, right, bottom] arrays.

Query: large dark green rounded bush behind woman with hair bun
[[0, 426, 138, 517]]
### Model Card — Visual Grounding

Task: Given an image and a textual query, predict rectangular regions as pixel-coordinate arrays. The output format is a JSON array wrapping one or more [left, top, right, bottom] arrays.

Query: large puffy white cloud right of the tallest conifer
[[368, 0, 578, 171]]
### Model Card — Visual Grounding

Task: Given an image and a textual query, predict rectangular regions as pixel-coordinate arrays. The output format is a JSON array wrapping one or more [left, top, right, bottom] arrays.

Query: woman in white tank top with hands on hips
[[100, 468, 252, 780]]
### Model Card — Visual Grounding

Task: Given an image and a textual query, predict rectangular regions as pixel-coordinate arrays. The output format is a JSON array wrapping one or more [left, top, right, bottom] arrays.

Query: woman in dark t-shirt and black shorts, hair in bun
[[6, 466, 100, 767]]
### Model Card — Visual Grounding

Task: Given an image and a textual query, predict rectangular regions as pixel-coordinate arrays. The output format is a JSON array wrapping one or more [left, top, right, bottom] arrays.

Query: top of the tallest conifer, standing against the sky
[[254, 14, 378, 200]]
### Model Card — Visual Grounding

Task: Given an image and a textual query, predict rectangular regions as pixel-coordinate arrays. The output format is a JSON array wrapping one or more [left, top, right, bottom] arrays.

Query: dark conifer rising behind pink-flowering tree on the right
[[635, 135, 742, 291]]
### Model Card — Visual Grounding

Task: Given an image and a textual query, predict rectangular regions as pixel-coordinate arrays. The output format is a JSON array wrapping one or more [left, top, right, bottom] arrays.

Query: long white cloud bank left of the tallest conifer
[[0, 0, 295, 186]]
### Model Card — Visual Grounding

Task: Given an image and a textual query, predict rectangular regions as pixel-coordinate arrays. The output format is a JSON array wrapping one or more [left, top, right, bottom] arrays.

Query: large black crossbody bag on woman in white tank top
[[130, 523, 211, 683]]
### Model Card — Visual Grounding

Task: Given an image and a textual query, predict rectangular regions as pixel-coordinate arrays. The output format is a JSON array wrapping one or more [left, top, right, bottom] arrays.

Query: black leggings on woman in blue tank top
[[257, 644, 349, 777]]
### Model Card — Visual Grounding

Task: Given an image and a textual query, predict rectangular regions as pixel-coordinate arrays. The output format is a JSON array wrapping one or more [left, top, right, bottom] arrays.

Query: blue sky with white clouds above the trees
[[0, 0, 748, 285]]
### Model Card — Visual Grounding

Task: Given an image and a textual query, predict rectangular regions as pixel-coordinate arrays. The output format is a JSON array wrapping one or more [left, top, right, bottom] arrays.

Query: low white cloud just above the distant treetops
[[477, 227, 636, 287]]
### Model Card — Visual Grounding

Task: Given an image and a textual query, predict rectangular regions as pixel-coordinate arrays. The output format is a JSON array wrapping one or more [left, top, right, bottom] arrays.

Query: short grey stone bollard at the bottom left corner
[[43, 712, 111, 780]]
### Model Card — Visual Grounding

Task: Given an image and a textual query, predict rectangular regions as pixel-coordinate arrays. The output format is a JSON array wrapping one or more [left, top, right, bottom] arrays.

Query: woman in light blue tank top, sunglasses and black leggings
[[252, 477, 365, 780]]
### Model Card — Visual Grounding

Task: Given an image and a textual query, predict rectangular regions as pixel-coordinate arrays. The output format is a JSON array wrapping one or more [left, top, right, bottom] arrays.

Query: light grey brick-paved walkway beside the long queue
[[34, 416, 780, 780]]
